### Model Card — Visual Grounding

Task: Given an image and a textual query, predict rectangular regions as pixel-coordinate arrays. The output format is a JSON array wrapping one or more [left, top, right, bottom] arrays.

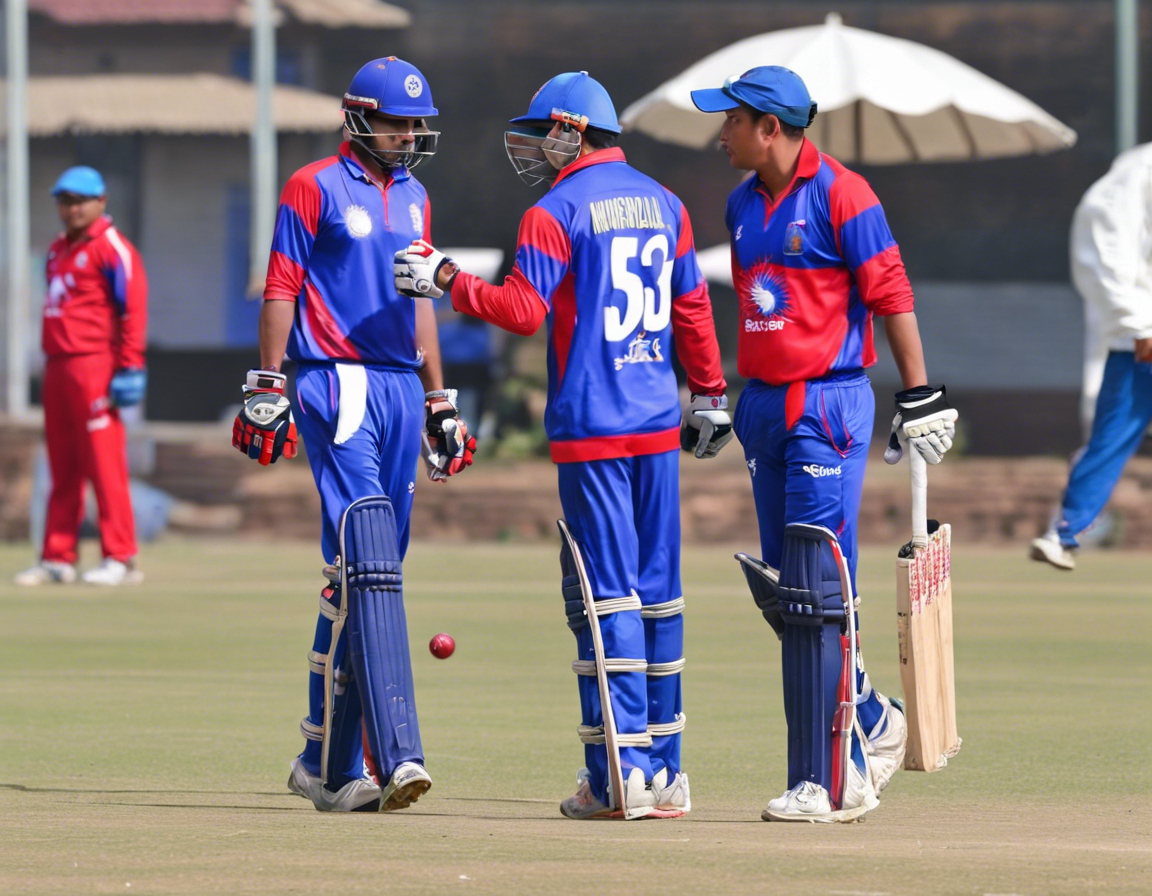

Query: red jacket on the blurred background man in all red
[[40, 215, 147, 367]]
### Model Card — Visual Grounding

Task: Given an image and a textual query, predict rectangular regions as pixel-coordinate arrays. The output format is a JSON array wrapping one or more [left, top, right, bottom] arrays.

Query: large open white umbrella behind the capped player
[[621, 13, 1076, 165]]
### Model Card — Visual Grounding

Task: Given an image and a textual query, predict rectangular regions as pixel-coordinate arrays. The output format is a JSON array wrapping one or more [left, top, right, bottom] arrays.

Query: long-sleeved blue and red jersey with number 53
[[452, 147, 726, 463]]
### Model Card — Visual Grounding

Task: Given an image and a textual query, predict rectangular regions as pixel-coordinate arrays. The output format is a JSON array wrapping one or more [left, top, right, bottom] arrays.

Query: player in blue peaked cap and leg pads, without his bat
[[692, 66, 956, 821]]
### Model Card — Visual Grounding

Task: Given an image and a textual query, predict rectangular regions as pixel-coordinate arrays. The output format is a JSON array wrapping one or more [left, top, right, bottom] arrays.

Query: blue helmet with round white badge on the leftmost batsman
[[340, 56, 440, 169]]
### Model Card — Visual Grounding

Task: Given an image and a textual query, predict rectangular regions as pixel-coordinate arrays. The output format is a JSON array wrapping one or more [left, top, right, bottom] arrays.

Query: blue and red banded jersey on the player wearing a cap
[[725, 139, 912, 386]]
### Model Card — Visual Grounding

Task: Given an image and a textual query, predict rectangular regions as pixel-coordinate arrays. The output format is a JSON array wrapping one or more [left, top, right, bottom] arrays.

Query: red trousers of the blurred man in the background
[[43, 354, 136, 563]]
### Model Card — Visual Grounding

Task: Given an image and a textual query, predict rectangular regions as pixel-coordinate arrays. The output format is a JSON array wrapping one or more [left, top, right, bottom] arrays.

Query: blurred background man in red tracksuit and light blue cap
[[15, 166, 147, 585]]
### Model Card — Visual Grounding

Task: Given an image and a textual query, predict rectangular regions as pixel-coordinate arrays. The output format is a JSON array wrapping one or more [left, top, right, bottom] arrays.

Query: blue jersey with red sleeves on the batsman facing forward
[[264, 143, 431, 369]]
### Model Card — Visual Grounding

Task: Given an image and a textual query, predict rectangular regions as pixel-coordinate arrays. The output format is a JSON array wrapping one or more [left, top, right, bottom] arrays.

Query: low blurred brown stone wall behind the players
[[0, 426, 1152, 548]]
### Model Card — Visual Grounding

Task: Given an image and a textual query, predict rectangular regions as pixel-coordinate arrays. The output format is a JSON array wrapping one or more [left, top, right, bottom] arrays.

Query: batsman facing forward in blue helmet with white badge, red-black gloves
[[233, 56, 476, 812]]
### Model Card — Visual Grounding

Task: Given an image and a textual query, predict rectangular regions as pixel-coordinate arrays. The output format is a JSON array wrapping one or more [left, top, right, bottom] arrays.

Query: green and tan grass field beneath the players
[[0, 540, 1152, 896]]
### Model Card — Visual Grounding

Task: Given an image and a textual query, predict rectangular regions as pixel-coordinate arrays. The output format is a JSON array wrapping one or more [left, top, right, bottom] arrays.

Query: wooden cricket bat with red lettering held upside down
[[896, 449, 961, 772]]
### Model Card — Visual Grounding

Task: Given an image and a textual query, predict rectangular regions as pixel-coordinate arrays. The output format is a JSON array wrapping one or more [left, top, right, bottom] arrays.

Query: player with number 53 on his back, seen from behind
[[395, 71, 732, 819]]
